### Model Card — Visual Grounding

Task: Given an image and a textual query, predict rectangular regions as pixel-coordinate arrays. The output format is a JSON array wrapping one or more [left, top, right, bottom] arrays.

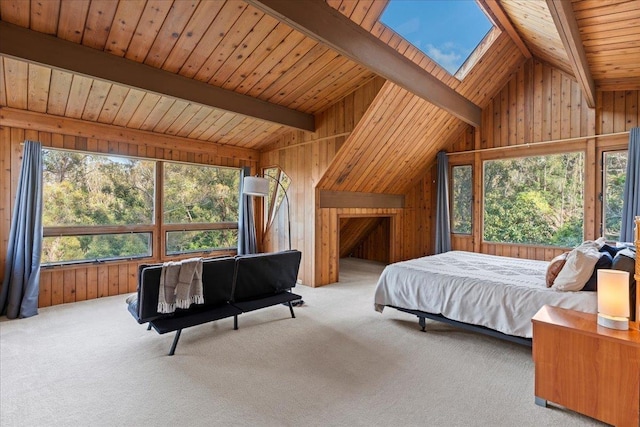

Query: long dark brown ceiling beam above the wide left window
[[0, 21, 315, 132]]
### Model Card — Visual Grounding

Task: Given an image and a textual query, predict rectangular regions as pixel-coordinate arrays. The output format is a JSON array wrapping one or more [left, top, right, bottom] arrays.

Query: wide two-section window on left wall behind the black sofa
[[42, 149, 240, 264]]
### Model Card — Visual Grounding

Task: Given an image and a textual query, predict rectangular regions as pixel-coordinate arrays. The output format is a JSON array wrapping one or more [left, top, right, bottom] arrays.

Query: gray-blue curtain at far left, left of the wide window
[[0, 141, 42, 319]]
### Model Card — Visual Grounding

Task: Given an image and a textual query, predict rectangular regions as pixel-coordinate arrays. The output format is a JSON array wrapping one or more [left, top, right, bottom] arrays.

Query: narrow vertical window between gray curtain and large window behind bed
[[451, 165, 473, 234]]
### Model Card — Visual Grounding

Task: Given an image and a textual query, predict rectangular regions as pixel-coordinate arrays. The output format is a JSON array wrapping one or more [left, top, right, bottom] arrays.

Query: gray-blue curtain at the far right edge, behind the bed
[[620, 128, 640, 242]]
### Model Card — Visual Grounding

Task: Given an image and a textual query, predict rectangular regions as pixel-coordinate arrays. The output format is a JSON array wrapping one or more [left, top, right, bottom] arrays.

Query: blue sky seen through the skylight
[[380, 0, 492, 74]]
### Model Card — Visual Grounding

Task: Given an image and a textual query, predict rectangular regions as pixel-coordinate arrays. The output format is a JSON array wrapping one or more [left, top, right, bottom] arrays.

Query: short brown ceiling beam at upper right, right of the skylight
[[547, 0, 596, 108]]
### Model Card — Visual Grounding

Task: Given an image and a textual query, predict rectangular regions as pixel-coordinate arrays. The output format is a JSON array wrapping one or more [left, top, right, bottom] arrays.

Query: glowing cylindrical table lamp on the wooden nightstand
[[598, 270, 630, 331]]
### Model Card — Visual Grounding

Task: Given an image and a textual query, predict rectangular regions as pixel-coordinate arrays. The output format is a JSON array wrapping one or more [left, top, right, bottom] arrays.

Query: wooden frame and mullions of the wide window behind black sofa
[[42, 147, 242, 268]]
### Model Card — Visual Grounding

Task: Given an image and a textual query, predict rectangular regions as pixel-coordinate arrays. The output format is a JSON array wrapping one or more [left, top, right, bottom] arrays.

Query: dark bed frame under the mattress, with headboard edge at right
[[398, 216, 640, 347]]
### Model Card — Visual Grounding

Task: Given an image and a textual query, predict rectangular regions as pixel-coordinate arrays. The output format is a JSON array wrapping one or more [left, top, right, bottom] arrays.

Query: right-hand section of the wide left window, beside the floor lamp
[[162, 163, 240, 255]]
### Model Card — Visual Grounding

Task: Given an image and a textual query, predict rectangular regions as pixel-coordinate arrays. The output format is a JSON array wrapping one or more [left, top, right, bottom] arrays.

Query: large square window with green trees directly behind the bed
[[483, 152, 584, 247]]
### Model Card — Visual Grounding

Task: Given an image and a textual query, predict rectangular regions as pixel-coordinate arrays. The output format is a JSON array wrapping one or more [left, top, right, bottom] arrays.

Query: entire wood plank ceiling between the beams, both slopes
[[0, 0, 640, 163]]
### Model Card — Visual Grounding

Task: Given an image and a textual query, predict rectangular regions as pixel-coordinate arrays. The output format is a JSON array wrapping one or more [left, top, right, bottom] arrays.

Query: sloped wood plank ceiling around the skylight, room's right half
[[318, 0, 640, 194]]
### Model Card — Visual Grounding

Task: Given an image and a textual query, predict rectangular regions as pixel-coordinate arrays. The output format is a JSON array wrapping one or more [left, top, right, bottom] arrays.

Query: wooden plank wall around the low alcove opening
[[260, 75, 432, 286]]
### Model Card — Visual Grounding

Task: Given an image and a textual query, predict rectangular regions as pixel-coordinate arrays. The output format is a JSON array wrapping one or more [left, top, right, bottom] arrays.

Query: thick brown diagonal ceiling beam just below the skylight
[[247, 0, 482, 127]]
